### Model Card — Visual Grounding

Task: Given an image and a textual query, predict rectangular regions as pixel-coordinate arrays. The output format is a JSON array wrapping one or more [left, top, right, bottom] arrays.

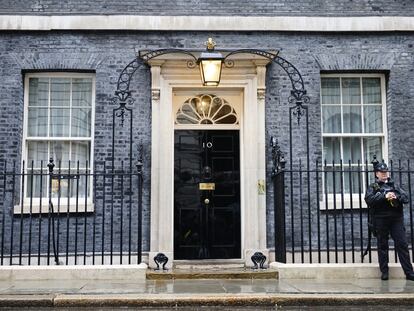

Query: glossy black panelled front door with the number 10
[[174, 130, 241, 259]]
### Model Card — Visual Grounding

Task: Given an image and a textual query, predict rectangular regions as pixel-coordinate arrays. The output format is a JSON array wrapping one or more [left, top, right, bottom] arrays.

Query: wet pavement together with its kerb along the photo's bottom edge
[[0, 279, 414, 311]]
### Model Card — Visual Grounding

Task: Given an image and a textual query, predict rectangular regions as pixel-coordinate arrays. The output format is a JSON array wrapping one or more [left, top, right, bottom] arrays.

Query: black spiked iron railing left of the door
[[0, 160, 143, 265]]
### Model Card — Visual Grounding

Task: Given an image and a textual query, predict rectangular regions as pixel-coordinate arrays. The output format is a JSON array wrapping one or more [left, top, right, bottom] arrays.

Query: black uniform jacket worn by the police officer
[[365, 178, 409, 217]]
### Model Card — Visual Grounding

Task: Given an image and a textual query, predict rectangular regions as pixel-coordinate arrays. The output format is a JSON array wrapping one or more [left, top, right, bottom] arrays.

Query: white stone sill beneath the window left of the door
[[13, 199, 95, 215]]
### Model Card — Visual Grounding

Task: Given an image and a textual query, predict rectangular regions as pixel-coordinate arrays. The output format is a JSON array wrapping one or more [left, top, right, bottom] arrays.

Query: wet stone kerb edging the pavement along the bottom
[[0, 294, 414, 307]]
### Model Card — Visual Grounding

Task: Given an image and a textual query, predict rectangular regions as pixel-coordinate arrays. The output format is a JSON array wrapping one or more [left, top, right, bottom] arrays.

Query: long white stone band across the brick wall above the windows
[[0, 15, 414, 32]]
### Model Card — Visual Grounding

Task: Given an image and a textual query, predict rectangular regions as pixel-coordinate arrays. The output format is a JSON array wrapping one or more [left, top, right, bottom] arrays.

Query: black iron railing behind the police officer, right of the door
[[273, 161, 414, 263]]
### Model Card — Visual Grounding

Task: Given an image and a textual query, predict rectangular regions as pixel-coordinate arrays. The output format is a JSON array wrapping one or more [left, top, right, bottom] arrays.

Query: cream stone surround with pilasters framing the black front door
[[149, 55, 269, 268]]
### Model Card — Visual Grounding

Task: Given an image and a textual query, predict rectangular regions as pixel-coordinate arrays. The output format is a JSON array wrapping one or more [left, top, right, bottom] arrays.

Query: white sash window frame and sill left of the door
[[14, 72, 96, 214]]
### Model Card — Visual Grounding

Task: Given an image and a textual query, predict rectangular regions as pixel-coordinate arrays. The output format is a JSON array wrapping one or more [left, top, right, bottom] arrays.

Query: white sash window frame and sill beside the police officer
[[320, 73, 388, 210]]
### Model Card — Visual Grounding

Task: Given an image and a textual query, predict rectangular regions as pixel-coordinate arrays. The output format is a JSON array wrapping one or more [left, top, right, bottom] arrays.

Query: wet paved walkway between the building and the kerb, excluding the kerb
[[0, 279, 414, 297]]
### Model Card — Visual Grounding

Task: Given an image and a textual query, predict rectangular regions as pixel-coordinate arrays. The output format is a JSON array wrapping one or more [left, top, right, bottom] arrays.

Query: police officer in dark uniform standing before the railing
[[365, 162, 414, 281]]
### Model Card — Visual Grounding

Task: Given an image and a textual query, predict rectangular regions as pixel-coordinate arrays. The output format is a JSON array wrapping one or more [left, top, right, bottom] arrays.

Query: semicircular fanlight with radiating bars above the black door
[[175, 94, 239, 124]]
